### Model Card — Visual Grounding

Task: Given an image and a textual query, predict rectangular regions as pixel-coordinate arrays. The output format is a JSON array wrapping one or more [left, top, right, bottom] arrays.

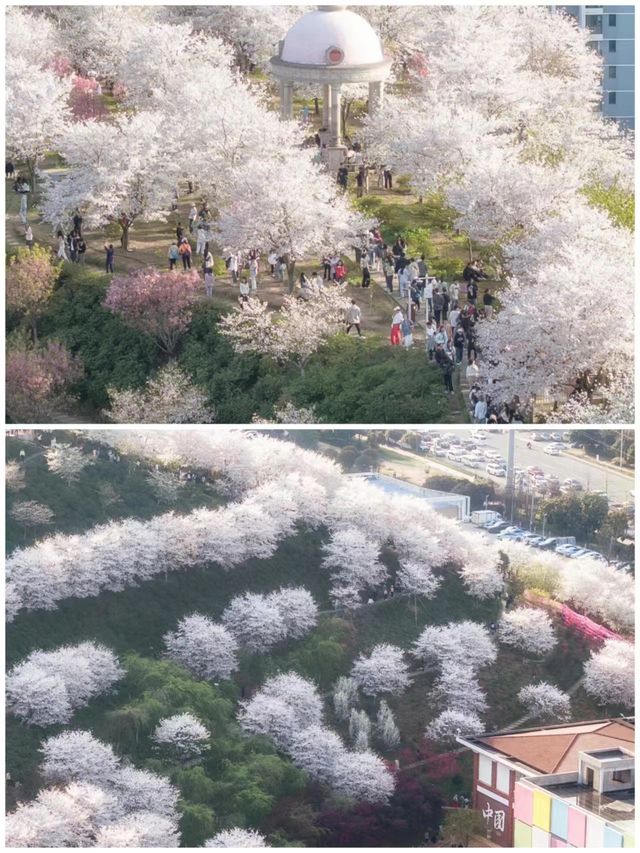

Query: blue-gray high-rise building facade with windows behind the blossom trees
[[557, 6, 635, 129]]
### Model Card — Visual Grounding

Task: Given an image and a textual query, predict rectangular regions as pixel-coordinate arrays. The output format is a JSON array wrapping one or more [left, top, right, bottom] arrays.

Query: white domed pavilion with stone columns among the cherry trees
[[271, 6, 391, 147]]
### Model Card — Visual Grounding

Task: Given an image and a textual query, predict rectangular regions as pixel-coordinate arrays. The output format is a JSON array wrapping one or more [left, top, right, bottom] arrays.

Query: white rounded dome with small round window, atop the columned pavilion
[[279, 6, 385, 68]]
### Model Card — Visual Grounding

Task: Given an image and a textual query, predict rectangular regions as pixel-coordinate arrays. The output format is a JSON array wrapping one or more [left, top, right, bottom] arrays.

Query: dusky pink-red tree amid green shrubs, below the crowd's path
[[104, 267, 201, 355]]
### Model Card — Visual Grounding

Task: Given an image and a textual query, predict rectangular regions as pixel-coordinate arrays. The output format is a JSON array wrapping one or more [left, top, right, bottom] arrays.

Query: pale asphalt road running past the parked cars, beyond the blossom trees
[[420, 430, 634, 503]]
